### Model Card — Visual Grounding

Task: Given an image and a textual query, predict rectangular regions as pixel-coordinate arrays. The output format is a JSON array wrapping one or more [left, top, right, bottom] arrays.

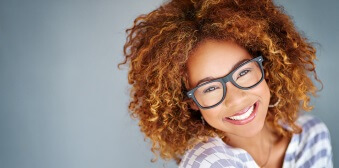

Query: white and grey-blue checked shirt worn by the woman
[[179, 114, 333, 168]]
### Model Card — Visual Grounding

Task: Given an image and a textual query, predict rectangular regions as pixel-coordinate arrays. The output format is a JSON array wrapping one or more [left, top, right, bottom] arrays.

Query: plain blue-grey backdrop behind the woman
[[0, 0, 339, 168]]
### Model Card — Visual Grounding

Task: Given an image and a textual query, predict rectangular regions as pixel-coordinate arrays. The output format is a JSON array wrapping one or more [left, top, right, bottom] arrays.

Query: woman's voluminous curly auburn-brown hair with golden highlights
[[118, 0, 323, 164]]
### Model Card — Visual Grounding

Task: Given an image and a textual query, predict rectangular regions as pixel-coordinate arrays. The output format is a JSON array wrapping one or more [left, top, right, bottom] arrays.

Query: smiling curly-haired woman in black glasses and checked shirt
[[119, 0, 333, 168]]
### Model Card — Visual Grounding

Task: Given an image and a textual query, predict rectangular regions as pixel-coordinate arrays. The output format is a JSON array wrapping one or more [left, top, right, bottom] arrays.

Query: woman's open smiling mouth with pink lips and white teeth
[[224, 101, 259, 125]]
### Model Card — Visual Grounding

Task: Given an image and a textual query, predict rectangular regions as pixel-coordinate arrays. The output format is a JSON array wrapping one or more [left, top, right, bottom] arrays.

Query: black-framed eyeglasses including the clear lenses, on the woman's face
[[186, 56, 264, 109]]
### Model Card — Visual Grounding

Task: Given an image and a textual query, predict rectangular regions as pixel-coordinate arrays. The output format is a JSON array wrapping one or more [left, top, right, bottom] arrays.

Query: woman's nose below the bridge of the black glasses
[[223, 82, 246, 108]]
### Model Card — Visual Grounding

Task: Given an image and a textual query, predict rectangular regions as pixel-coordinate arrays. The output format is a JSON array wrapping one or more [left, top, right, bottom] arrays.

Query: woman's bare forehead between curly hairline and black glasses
[[187, 40, 252, 87]]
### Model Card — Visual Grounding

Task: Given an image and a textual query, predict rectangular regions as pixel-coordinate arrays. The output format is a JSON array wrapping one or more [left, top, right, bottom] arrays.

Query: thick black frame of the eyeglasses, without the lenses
[[186, 55, 265, 109]]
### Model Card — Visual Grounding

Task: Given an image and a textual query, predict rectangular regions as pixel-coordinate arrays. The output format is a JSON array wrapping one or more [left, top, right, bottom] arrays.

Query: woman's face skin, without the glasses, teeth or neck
[[187, 40, 270, 137]]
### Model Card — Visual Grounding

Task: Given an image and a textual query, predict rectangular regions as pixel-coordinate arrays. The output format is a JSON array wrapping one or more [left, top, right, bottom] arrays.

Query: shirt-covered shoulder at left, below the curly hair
[[179, 137, 254, 168]]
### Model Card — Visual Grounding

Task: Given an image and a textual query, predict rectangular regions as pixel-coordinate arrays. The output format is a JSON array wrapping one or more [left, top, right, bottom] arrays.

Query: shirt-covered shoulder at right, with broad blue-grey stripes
[[291, 114, 332, 167]]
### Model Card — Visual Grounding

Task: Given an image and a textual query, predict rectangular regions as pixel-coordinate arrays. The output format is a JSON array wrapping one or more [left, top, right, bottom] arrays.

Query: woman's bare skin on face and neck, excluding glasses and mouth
[[187, 40, 289, 167]]
